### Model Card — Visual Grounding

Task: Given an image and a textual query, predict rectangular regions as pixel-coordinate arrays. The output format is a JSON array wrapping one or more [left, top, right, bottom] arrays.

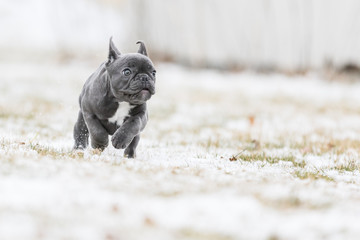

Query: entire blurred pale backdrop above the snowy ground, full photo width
[[4, 0, 360, 73]]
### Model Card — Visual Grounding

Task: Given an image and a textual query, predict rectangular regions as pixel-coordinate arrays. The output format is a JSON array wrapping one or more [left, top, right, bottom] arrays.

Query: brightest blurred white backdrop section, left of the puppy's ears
[[0, 0, 124, 61]]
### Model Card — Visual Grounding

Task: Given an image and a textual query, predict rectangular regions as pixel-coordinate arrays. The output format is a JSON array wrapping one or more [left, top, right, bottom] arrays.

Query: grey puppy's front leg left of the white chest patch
[[84, 113, 109, 151]]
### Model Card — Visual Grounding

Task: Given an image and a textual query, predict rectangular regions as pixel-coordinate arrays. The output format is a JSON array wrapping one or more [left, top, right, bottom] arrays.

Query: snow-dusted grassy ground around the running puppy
[[0, 62, 360, 239]]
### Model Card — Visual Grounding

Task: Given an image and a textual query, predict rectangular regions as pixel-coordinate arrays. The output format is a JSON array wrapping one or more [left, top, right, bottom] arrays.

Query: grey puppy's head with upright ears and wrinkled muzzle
[[105, 38, 156, 104]]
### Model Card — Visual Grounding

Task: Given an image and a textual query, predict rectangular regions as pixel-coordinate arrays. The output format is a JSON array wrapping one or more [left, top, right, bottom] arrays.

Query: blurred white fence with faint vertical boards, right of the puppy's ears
[[129, 0, 360, 70]]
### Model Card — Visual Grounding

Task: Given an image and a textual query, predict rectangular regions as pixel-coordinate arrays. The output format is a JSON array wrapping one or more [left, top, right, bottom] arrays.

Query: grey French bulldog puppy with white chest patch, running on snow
[[74, 38, 156, 158]]
